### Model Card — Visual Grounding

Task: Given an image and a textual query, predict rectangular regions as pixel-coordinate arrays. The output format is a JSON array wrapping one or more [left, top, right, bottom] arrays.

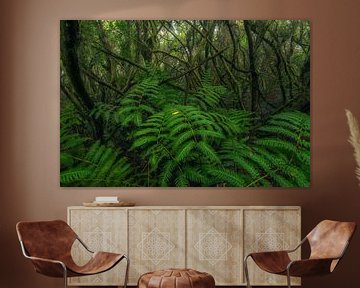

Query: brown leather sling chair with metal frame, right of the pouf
[[244, 220, 356, 288]]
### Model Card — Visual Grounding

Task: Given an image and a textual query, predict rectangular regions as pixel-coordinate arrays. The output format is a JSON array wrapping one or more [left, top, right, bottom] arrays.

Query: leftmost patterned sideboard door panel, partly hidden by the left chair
[[68, 208, 128, 286]]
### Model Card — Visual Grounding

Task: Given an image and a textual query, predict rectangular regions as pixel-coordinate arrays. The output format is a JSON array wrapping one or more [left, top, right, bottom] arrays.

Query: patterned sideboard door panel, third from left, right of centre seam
[[186, 209, 243, 285]]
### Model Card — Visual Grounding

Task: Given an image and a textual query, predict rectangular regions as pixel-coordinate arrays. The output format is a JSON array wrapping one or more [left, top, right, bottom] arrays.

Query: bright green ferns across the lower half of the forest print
[[60, 73, 310, 187]]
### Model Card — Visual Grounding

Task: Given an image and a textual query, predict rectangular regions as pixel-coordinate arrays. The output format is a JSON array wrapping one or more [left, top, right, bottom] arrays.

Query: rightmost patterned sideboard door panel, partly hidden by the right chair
[[244, 207, 301, 285]]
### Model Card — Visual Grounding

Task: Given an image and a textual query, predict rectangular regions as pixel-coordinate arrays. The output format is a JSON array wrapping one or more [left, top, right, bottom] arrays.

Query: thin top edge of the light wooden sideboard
[[68, 206, 301, 210]]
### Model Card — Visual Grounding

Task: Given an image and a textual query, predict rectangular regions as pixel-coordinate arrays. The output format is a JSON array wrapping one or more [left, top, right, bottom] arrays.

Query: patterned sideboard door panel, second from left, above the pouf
[[129, 209, 186, 284]]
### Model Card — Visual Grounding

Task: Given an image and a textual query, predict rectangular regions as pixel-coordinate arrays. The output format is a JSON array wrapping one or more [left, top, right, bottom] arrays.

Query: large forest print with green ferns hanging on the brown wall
[[60, 20, 310, 188]]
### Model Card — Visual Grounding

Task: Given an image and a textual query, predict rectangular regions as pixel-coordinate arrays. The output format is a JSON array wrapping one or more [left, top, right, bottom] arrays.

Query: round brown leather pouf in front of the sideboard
[[138, 269, 215, 288]]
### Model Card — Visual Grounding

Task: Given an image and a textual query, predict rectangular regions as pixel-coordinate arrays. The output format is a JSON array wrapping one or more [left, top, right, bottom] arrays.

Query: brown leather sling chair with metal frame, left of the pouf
[[16, 220, 129, 288]]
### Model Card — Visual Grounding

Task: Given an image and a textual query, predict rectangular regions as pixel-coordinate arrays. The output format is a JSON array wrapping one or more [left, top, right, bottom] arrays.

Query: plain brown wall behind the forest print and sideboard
[[0, 0, 360, 288]]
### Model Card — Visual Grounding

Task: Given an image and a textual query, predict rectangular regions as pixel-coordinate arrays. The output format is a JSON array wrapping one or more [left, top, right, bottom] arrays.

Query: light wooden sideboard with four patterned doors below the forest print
[[68, 206, 301, 286]]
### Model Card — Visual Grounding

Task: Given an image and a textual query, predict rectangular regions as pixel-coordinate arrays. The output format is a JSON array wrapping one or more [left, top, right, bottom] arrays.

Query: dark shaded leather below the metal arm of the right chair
[[287, 258, 339, 277]]
